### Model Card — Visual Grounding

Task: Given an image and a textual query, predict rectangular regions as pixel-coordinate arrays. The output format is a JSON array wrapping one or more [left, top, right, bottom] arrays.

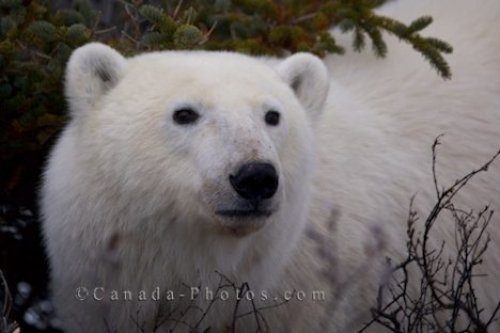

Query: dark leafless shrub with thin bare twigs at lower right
[[359, 137, 500, 333]]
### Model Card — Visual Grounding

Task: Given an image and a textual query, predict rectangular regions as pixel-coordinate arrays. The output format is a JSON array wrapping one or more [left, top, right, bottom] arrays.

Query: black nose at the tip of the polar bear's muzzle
[[229, 162, 278, 203]]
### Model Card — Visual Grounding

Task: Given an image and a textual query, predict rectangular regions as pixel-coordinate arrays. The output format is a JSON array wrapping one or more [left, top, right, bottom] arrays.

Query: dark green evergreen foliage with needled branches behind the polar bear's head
[[0, 0, 452, 201]]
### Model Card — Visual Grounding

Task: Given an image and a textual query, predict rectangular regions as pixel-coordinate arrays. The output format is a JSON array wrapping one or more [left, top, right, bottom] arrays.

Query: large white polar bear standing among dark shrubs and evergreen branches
[[41, 0, 500, 332]]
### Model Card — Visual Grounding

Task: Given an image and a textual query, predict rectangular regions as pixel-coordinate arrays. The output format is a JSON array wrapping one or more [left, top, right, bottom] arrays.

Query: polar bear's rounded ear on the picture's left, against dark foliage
[[65, 43, 127, 116]]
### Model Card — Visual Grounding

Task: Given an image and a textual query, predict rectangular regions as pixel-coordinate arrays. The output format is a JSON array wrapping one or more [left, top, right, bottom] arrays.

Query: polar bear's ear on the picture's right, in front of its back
[[278, 53, 330, 119]]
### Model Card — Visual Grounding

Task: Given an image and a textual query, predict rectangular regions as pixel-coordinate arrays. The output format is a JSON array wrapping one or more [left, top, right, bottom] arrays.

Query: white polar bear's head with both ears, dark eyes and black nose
[[66, 44, 328, 236]]
